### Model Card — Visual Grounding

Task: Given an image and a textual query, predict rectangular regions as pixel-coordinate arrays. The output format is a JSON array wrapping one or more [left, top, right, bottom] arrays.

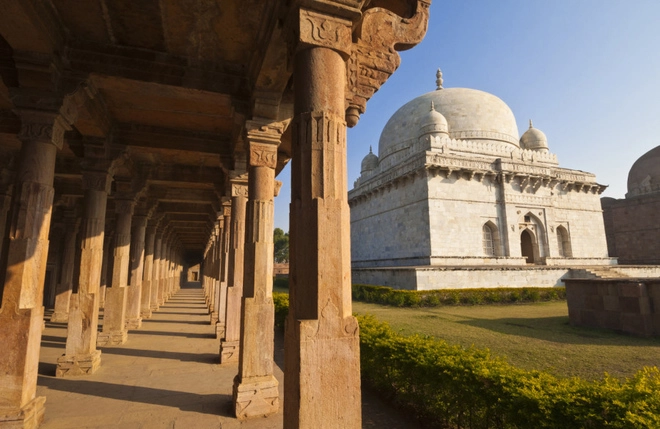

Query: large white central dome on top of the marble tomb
[[378, 88, 519, 160]]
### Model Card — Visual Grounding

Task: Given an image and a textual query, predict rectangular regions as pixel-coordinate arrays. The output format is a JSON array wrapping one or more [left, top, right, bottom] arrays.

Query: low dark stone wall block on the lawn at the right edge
[[564, 278, 660, 337]]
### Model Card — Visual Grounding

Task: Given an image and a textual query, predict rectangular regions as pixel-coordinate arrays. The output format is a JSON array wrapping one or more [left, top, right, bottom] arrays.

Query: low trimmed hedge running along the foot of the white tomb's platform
[[353, 284, 566, 307]]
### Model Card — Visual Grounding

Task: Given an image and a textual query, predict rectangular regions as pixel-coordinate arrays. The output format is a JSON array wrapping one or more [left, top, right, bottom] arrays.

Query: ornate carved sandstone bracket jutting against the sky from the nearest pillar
[[346, 0, 431, 127]]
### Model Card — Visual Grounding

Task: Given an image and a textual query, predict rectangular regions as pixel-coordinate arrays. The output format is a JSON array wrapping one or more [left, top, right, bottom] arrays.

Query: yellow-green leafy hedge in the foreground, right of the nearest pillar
[[273, 293, 660, 429]]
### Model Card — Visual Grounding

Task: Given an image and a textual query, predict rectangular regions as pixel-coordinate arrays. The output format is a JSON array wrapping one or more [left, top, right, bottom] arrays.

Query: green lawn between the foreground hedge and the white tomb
[[353, 302, 660, 380]]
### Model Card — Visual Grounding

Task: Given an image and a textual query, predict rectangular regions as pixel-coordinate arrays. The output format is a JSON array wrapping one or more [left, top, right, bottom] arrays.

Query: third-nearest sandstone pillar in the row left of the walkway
[[96, 200, 135, 347]]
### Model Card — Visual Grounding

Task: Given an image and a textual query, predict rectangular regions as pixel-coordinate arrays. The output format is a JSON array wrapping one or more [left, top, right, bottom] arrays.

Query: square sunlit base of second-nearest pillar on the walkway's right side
[[233, 375, 280, 420]]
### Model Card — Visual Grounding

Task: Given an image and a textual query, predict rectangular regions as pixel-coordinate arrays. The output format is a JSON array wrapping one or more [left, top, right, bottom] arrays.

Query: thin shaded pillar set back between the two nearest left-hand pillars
[[50, 209, 80, 323]]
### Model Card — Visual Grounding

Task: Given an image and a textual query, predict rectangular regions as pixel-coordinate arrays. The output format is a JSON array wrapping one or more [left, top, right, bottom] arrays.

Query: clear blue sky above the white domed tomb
[[275, 0, 660, 231]]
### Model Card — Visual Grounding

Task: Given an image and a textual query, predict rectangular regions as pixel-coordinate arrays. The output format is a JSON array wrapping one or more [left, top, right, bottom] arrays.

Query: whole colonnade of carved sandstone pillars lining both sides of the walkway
[[0, 0, 430, 428]]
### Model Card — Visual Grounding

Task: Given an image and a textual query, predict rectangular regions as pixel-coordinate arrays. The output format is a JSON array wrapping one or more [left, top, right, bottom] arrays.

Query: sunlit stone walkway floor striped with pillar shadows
[[37, 283, 418, 429]]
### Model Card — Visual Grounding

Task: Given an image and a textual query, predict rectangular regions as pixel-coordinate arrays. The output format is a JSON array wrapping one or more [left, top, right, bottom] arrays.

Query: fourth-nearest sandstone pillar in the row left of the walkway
[[126, 215, 147, 329]]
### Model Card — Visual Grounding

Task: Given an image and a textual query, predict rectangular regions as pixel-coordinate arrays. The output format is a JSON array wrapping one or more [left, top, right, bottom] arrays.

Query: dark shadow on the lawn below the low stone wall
[[456, 316, 660, 347]]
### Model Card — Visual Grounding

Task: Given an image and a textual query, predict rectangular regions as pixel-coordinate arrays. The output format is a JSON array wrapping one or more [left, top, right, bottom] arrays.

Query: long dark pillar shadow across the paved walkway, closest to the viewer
[[37, 371, 232, 417]]
